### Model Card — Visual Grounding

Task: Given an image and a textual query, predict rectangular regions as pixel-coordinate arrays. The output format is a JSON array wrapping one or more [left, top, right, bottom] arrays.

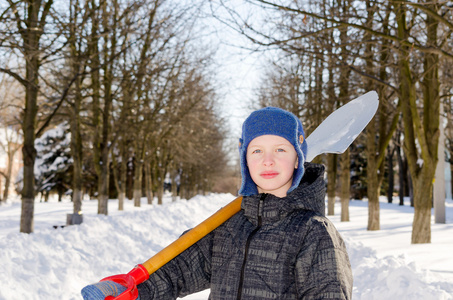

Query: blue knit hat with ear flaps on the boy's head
[[239, 107, 307, 196]]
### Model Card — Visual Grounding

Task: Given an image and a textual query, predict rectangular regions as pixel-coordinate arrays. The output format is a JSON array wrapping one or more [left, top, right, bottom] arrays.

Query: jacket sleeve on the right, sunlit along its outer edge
[[295, 217, 352, 300]]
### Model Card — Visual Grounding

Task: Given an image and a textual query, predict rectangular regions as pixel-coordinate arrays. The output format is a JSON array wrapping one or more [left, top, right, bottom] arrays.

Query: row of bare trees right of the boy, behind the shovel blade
[[213, 0, 453, 243]]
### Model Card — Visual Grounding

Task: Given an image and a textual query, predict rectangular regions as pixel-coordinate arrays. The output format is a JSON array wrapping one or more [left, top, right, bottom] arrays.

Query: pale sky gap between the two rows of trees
[[200, 0, 266, 139]]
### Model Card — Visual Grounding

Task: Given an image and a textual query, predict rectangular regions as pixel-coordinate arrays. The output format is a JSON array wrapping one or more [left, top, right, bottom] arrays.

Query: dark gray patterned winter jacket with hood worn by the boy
[[138, 163, 352, 300]]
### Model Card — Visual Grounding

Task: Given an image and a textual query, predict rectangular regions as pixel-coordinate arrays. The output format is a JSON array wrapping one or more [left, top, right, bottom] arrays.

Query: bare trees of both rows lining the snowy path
[[0, 0, 453, 243]]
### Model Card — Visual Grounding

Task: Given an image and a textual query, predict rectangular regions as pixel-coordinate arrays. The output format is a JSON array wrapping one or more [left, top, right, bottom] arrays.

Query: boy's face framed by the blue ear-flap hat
[[247, 135, 298, 197]]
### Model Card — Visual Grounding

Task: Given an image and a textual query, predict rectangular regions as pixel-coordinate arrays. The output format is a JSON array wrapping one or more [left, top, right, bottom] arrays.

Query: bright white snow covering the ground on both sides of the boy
[[0, 194, 453, 300]]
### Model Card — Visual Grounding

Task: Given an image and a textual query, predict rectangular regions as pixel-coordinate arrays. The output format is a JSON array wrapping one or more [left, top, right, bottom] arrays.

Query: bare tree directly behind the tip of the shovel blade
[[363, 1, 399, 230]]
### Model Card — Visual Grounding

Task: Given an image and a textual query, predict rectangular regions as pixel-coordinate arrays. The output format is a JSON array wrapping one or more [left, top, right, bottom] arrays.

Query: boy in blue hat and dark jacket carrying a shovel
[[82, 107, 352, 300]]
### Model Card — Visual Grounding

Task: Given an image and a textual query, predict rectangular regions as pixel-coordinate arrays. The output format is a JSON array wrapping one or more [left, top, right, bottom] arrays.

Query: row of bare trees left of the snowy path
[[0, 0, 230, 233]]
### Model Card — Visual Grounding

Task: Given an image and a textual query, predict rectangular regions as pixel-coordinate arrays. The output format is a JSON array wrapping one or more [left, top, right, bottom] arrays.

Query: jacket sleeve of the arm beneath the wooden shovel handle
[[137, 232, 213, 300]]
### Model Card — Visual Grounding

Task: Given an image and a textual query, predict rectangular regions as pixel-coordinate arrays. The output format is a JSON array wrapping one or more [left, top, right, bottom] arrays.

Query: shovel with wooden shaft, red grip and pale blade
[[93, 91, 379, 300]]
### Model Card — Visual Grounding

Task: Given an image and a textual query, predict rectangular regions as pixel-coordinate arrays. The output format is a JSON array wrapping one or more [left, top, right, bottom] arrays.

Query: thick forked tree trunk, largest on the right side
[[396, 4, 440, 244]]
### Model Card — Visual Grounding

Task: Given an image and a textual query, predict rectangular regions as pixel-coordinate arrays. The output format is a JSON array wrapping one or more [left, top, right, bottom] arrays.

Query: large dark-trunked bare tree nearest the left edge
[[0, 0, 63, 233]]
